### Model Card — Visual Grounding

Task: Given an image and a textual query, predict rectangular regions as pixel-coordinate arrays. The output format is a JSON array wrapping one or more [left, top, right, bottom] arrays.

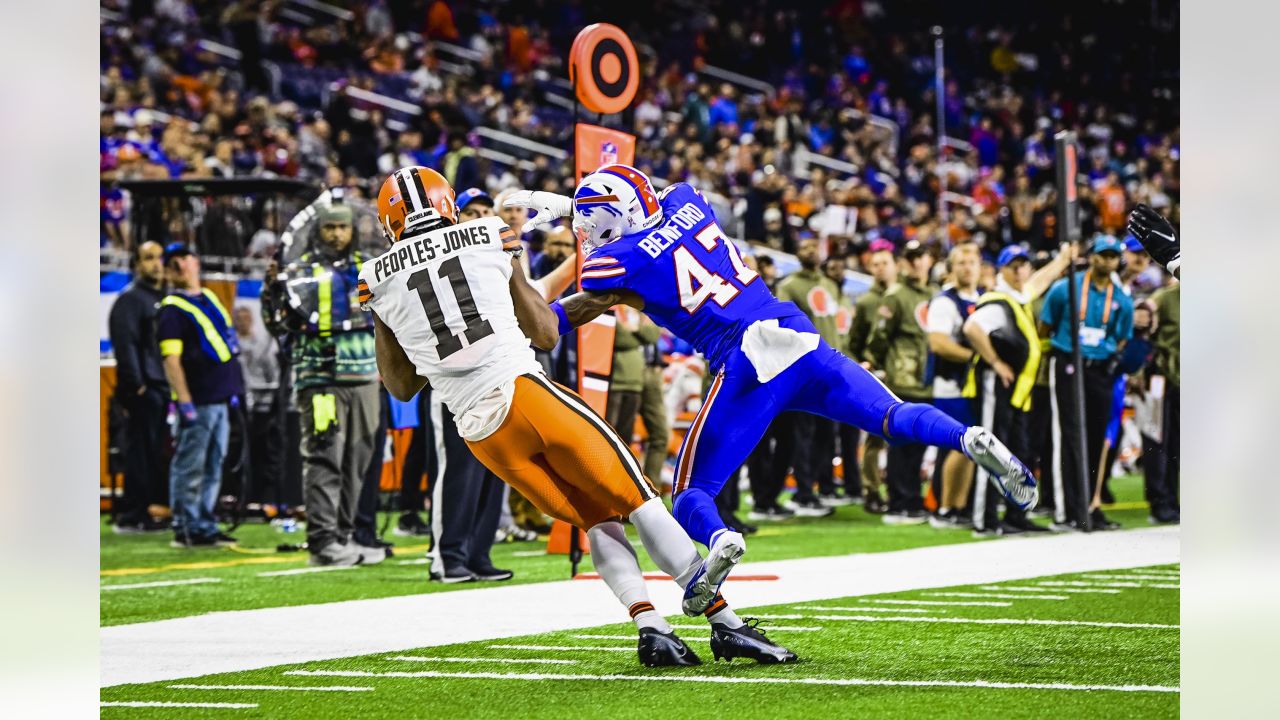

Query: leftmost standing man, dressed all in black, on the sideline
[[108, 242, 169, 534]]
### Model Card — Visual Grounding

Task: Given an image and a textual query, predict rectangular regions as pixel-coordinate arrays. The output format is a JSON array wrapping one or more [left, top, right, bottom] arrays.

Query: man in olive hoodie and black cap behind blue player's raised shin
[[867, 241, 937, 525]]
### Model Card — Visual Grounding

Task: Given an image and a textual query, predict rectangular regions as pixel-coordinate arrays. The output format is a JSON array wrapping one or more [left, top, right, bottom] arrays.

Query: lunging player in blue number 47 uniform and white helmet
[[507, 164, 1038, 617]]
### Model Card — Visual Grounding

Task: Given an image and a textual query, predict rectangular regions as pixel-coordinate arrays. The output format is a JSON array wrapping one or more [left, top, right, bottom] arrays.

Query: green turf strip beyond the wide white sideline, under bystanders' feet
[[100, 477, 1162, 625]]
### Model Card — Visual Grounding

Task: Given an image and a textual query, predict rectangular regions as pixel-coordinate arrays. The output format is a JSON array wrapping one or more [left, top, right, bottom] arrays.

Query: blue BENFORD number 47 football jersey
[[581, 183, 800, 368]]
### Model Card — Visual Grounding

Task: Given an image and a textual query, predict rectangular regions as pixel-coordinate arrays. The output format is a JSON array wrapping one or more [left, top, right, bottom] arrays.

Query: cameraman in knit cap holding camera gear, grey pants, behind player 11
[[262, 202, 387, 566]]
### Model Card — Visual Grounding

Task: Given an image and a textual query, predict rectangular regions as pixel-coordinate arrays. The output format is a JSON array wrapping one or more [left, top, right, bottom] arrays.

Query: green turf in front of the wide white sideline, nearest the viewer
[[101, 563, 1180, 720]]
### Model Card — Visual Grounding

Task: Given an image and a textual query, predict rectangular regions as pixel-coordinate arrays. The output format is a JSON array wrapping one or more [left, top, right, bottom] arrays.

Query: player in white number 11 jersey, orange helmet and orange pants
[[360, 167, 795, 666]]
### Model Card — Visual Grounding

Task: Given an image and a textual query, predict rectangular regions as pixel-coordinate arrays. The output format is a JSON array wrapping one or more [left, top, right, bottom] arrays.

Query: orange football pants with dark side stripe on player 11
[[467, 373, 659, 530]]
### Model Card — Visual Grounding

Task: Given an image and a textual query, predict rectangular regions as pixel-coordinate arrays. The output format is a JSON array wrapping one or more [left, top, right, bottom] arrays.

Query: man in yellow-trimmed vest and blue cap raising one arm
[[963, 245, 1071, 534]]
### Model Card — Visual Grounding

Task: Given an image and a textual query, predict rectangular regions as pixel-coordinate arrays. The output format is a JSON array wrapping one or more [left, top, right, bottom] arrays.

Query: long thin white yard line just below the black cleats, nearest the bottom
[[285, 670, 1181, 693]]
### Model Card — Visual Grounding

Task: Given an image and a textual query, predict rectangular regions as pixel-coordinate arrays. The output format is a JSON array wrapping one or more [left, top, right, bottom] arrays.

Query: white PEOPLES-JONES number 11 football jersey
[[360, 218, 541, 439]]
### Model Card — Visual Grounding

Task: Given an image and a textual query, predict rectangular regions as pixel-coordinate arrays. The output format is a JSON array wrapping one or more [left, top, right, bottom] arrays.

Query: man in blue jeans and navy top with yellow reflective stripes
[[156, 242, 244, 547]]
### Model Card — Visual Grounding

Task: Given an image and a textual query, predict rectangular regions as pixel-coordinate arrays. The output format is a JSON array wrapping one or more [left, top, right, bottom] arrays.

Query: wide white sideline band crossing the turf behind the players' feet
[[99, 527, 1181, 687]]
